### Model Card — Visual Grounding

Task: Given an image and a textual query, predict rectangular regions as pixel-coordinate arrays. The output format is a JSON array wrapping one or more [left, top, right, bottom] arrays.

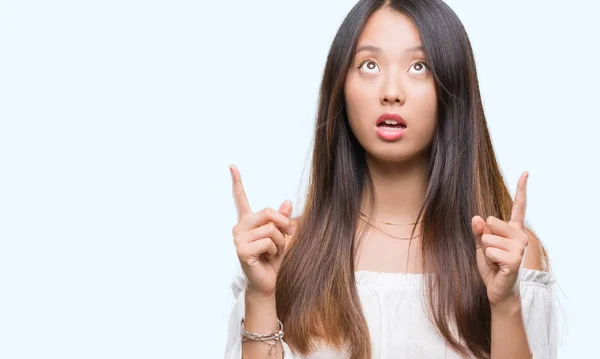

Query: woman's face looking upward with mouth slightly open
[[344, 7, 437, 162]]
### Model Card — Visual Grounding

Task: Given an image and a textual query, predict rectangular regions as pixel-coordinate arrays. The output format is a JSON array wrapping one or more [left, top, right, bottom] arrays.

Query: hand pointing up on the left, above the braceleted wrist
[[229, 166, 293, 297]]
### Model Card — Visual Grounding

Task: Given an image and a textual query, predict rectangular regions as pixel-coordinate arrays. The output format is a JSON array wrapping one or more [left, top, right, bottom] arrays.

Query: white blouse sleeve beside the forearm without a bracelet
[[519, 267, 558, 359]]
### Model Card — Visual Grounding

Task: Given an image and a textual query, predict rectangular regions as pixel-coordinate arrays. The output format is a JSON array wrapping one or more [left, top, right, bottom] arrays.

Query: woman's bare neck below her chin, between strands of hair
[[361, 153, 429, 223]]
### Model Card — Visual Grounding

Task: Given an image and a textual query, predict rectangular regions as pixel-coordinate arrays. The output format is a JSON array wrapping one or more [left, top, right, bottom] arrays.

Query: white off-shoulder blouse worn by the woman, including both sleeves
[[225, 268, 557, 359]]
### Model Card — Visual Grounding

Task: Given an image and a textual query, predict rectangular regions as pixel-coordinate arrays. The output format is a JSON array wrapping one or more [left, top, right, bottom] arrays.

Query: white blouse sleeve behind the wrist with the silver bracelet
[[225, 270, 294, 359]]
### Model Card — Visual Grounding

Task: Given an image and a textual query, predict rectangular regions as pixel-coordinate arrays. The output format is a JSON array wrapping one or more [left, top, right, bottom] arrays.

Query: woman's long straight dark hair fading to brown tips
[[276, 0, 512, 359]]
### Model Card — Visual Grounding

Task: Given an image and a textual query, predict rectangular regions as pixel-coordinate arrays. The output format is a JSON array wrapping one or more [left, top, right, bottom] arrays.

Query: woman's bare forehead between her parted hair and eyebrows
[[358, 6, 421, 54]]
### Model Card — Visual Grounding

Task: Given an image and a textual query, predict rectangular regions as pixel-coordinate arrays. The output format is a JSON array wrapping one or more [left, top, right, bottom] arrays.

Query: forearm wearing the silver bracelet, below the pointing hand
[[242, 293, 283, 359]]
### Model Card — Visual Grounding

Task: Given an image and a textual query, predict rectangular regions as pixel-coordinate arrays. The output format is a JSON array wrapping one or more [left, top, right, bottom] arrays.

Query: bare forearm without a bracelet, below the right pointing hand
[[491, 297, 532, 359]]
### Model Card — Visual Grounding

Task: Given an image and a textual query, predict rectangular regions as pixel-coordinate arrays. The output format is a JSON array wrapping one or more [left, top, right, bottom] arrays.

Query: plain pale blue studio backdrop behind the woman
[[0, 0, 600, 359]]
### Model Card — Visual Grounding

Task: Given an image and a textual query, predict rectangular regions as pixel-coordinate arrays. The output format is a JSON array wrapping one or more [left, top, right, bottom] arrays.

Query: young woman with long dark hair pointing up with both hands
[[225, 0, 556, 359]]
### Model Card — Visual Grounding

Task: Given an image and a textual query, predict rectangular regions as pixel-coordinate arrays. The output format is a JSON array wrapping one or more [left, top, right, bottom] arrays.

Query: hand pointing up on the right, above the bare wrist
[[471, 172, 529, 309]]
